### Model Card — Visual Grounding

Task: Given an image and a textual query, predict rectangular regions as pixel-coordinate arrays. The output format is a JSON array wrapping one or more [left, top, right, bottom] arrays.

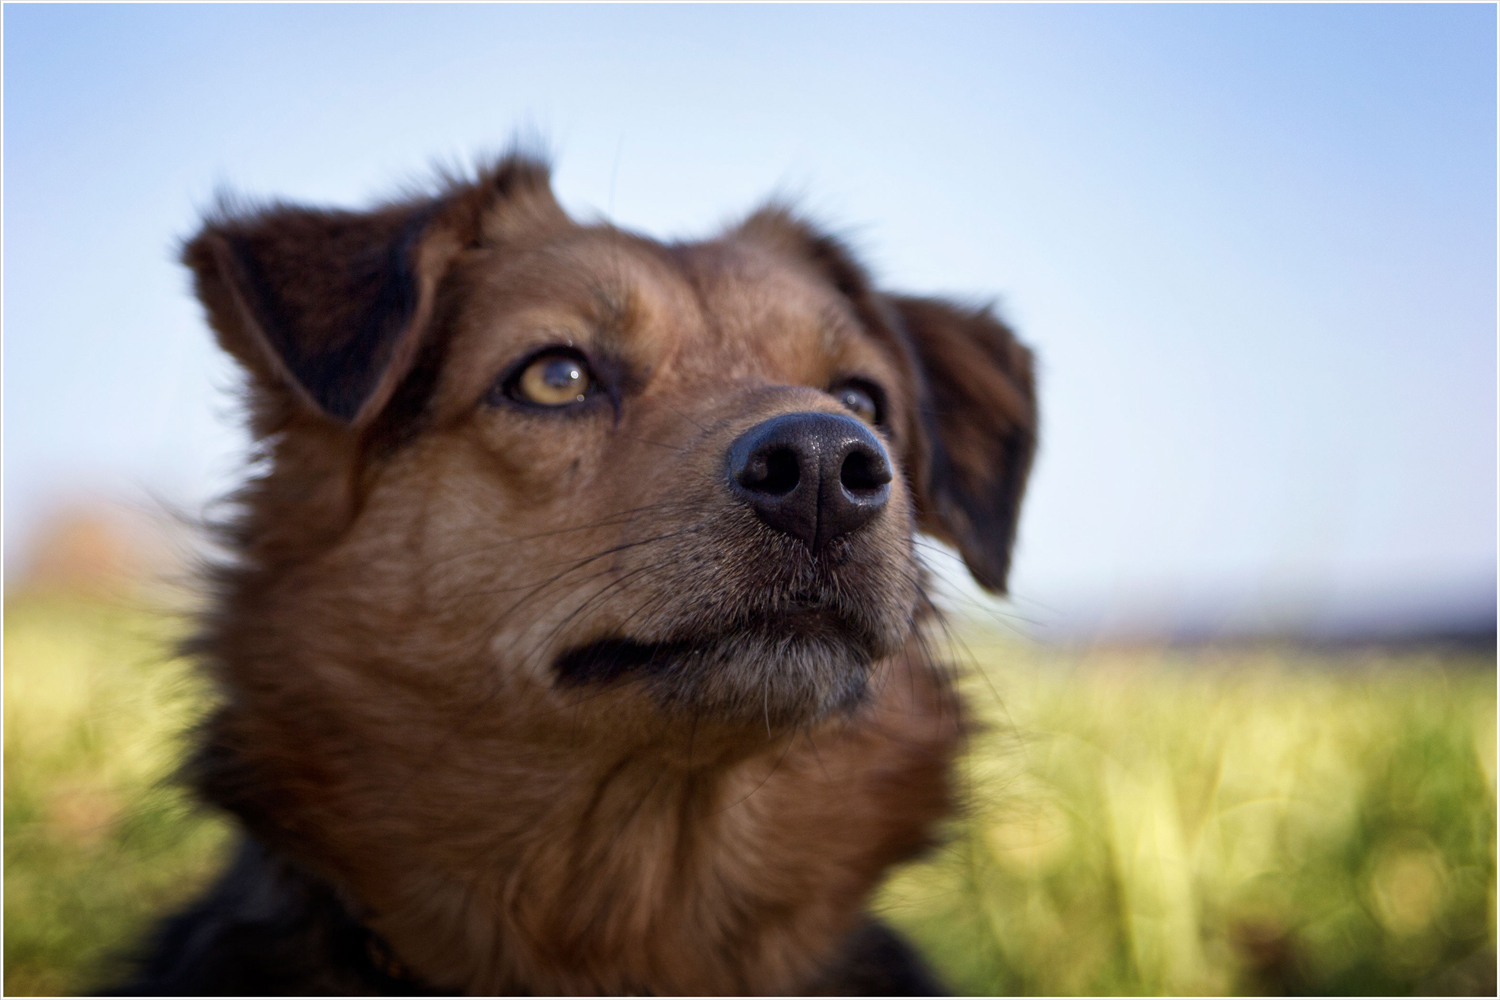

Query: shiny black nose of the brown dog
[[729, 414, 891, 555]]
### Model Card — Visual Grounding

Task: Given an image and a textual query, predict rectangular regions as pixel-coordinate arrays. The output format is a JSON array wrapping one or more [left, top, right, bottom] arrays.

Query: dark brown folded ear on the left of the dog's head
[[183, 156, 566, 427]]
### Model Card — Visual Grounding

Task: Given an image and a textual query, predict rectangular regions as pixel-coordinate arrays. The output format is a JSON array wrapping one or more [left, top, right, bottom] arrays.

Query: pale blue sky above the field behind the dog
[[3, 4, 1496, 632]]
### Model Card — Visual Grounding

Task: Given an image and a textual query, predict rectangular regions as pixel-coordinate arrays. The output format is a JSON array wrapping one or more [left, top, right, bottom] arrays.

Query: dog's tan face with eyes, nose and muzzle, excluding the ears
[[426, 228, 917, 723]]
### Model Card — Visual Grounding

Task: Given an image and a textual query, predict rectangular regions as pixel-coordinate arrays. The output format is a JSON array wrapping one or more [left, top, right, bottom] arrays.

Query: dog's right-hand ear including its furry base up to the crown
[[737, 204, 1037, 594]]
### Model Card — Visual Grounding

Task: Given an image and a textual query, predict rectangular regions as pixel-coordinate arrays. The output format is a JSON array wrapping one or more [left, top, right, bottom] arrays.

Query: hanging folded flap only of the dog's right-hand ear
[[887, 295, 1037, 594]]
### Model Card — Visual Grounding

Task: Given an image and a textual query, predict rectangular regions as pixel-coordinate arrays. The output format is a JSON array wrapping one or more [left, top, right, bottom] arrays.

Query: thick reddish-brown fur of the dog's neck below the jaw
[[198, 632, 962, 994]]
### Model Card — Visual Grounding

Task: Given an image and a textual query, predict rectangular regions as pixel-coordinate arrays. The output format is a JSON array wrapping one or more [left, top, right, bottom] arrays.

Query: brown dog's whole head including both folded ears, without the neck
[[186, 160, 1035, 743]]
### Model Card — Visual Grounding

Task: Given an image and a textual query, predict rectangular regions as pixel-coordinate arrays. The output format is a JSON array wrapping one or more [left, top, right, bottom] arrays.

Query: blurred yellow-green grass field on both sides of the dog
[[5, 595, 1496, 994]]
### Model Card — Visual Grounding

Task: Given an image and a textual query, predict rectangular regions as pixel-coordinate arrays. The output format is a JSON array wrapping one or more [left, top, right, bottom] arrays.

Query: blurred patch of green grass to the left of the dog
[[5, 600, 227, 996]]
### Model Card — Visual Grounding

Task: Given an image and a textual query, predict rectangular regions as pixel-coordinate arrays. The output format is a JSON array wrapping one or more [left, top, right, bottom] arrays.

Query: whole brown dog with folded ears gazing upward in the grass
[[119, 153, 1037, 994]]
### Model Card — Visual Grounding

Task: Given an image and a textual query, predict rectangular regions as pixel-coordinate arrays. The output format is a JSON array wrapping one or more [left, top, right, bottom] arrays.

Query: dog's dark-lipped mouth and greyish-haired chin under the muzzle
[[554, 613, 896, 727]]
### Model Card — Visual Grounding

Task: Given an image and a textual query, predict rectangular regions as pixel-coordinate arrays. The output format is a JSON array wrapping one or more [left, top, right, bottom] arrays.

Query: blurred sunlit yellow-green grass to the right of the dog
[[884, 636, 1496, 994]]
